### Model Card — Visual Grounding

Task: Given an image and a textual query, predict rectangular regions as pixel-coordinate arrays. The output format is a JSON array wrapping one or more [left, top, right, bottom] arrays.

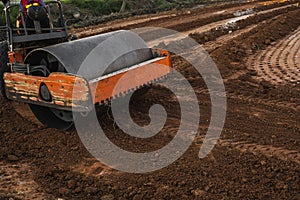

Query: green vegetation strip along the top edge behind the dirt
[[0, 0, 222, 26]]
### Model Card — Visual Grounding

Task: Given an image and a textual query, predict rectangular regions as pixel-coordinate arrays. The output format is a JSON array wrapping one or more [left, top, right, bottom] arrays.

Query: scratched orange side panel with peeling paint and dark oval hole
[[4, 73, 89, 110]]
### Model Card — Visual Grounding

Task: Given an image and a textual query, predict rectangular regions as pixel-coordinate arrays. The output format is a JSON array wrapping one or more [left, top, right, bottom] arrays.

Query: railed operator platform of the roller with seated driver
[[4, 1, 68, 51]]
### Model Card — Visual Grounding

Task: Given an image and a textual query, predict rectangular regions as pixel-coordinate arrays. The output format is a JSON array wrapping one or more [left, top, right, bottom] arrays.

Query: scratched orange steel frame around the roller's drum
[[4, 49, 172, 112]]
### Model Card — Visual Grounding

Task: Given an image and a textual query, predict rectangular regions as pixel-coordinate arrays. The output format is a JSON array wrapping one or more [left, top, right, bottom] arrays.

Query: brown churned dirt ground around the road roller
[[0, 0, 300, 200]]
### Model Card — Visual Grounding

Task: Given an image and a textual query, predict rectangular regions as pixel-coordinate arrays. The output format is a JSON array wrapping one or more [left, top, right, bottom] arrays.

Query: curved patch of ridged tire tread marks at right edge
[[248, 28, 300, 84]]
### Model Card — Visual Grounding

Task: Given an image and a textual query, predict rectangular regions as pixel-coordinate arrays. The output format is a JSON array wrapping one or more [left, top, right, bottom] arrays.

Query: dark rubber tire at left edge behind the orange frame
[[0, 41, 10, 98]]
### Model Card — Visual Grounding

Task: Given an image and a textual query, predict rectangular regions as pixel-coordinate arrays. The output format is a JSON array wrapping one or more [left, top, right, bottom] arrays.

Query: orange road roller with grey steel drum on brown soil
[[0, 1, 172, 130]]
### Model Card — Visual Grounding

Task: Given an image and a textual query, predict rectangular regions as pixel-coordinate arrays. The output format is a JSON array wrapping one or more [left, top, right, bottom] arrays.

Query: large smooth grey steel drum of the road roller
[[25, 31, 153, 130]]
